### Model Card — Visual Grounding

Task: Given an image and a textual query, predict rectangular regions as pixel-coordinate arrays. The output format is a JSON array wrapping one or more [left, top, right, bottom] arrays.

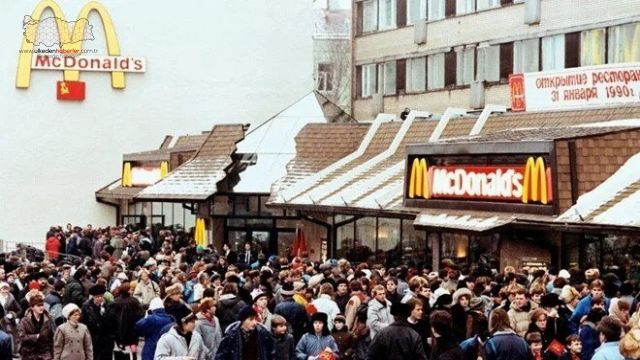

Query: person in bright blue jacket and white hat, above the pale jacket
[[136, 298, 176, 360]]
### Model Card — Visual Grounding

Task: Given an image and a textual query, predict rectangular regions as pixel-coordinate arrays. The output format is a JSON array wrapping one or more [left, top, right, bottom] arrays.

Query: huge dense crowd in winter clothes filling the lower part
[[0, 225, 640, 360]]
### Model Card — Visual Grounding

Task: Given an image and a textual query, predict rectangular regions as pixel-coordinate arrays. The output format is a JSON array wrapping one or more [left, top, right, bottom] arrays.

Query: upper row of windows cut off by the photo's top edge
[[356, 0, 524, 35]]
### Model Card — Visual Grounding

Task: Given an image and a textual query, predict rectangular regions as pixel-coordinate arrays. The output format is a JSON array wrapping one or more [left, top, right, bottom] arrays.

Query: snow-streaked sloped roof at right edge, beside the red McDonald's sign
[[556, 153, 640, 227]]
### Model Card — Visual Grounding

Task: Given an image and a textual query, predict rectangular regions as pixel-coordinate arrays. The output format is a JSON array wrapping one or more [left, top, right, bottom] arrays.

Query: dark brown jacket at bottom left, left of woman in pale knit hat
[[18, 308, 53, 360]]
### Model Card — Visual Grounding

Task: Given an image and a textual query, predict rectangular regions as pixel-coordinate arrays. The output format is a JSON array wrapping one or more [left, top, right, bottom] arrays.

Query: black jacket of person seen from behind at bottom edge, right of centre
[[369, 320, 427, 360]]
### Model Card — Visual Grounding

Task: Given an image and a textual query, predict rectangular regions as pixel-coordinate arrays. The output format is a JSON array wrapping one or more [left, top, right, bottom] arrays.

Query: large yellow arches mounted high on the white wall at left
[[16, 0, 125, 89]]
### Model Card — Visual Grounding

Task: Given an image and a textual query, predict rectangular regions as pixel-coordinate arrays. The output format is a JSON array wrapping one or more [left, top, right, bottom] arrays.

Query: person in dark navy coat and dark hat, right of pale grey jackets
[[216, 306, 276, 360]]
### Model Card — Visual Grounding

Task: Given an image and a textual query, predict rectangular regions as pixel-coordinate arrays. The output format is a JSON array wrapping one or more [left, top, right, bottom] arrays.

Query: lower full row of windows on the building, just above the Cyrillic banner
[[355, 23, 640, 97]]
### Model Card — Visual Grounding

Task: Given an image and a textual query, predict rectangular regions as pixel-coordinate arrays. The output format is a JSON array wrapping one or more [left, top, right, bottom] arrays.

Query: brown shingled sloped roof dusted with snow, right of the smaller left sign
[[136, 124, 244, 201]]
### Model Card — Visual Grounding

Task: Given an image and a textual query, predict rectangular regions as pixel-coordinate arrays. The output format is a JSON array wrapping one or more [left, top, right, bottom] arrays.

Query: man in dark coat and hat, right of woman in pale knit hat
[[80, 284, 113, 360]]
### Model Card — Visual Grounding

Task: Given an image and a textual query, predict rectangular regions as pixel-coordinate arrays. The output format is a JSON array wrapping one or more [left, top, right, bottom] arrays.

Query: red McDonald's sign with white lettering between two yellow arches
[[406, 156, 553, 205]]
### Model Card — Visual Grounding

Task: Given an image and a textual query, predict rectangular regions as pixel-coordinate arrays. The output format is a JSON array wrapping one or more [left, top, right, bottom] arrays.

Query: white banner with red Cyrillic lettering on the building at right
[[509, 63, 640, 111]]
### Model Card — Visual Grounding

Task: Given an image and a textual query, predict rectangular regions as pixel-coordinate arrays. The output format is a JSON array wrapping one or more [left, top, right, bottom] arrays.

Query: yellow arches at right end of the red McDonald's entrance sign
[[522, 157, 552, 205]]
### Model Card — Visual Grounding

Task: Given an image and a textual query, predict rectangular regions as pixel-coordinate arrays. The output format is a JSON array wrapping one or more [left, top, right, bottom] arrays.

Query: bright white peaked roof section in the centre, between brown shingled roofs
[[233, 92, 353, 193]]
